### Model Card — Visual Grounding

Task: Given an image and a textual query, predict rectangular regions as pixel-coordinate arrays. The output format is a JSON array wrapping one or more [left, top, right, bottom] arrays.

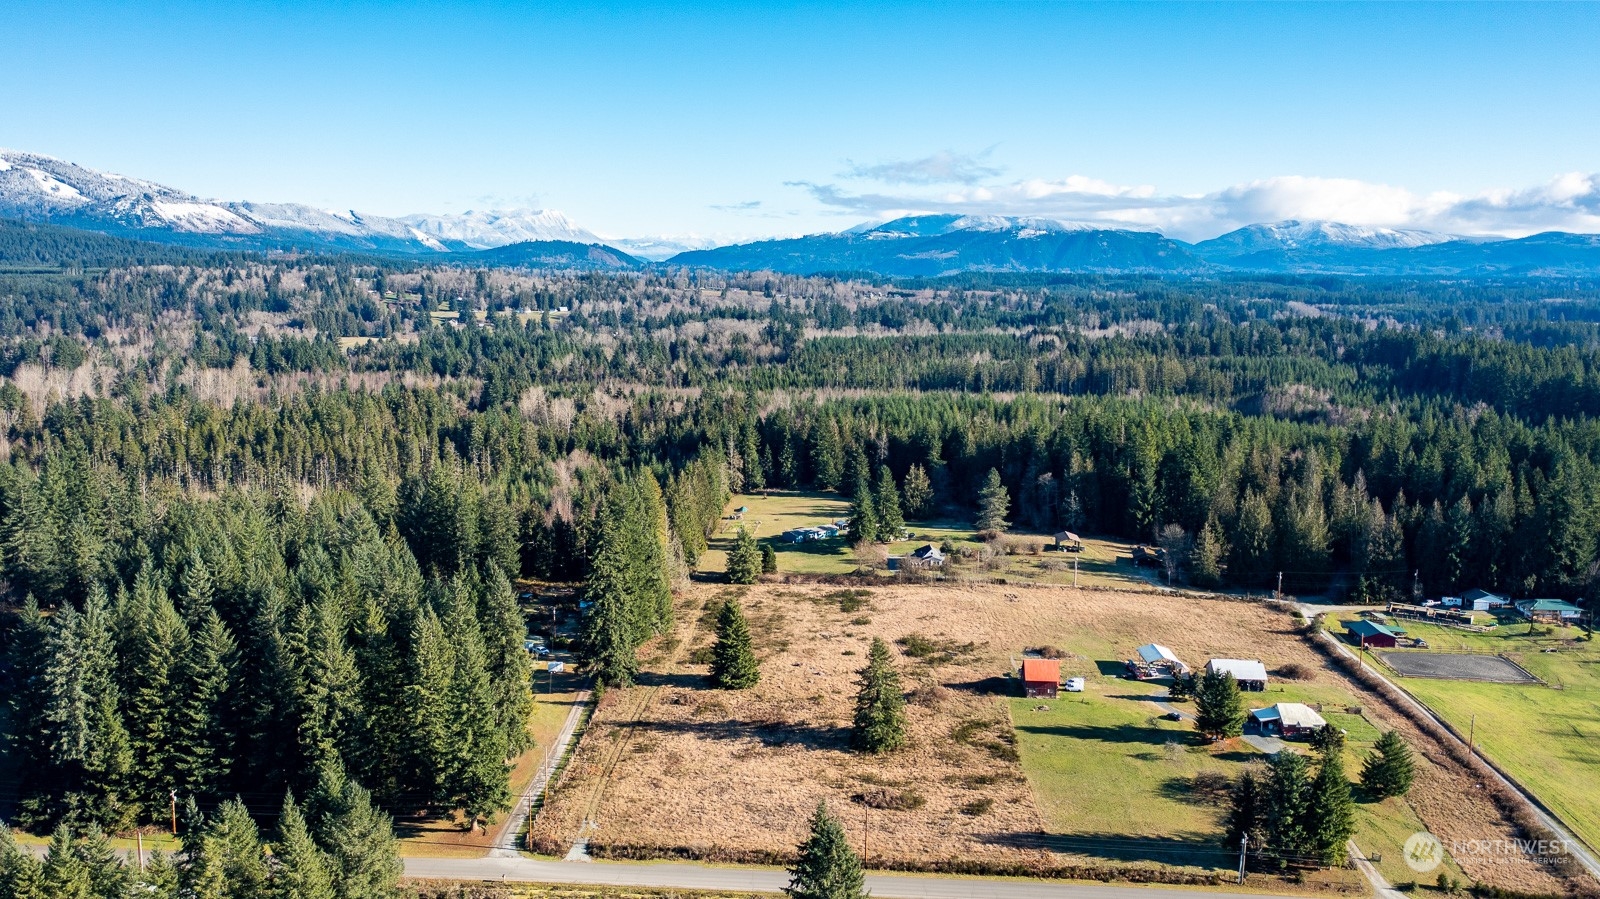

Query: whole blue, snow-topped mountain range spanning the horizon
[[0, 150, 1600, 277]]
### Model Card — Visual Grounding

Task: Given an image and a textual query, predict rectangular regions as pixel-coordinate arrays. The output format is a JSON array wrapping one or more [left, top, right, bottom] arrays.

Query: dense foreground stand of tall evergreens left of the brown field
[[5, 467, 531, 830]]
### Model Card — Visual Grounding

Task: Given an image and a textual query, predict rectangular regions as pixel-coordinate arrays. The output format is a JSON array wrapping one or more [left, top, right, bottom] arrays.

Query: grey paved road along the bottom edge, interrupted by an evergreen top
[[405, 857, 1299, 899]]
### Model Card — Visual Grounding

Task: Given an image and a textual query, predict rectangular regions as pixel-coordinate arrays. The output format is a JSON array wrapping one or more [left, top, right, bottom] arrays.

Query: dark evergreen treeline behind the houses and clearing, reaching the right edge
[[746, 394, 1600, 601]]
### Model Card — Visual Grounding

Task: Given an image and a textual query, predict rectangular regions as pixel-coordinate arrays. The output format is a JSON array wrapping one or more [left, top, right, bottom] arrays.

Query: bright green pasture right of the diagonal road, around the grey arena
[[1363, 621, 1600, 846]]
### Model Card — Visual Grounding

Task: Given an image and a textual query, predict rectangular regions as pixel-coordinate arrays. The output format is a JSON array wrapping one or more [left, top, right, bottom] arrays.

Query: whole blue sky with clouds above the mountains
[[0, 0, 1600, 238]]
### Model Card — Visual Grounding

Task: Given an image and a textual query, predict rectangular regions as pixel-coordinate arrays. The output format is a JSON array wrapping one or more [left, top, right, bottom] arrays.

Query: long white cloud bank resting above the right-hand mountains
[[792, 173, 1600, 240]]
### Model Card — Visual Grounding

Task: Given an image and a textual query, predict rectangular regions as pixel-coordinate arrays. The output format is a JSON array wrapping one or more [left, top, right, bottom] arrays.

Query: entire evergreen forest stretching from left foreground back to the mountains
[[0, 222, 1600, 889]]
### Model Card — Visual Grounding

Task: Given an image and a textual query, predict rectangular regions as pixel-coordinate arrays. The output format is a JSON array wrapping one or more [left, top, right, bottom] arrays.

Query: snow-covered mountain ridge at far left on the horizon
[[0, 150, 600, 253]]
